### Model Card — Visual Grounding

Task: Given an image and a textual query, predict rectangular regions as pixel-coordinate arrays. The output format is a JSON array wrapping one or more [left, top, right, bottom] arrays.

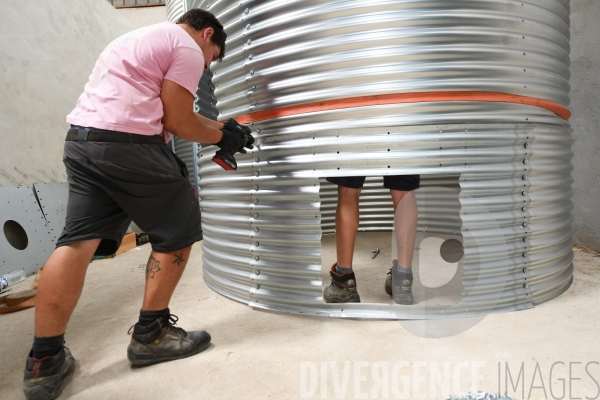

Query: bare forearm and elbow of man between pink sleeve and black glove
[[160, 79, 223, 144]]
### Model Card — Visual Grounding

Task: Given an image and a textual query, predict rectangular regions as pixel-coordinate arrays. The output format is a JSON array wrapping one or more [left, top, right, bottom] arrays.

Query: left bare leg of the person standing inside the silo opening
[[335, 186, 361, 268]]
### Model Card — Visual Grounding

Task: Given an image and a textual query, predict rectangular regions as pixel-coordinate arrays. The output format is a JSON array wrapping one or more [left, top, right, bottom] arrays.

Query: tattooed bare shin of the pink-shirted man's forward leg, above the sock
[[142, 246, 192, 311]]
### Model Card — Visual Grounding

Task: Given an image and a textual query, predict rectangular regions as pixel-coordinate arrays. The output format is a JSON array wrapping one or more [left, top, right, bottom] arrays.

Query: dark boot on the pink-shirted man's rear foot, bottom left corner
[[23, 346, 75, 400]]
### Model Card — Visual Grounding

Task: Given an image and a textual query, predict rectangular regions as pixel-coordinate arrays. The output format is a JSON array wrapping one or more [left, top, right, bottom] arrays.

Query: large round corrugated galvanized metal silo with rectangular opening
[[166, 0, 573, 318]]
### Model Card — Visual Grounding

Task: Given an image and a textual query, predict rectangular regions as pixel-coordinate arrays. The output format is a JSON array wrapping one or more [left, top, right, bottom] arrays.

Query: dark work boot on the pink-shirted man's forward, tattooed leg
[[127, 312, 210, 365]]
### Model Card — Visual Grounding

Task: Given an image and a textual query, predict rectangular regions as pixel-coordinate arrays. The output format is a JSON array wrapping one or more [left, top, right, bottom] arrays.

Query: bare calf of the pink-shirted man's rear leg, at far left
[[35, 239, 101, 338]]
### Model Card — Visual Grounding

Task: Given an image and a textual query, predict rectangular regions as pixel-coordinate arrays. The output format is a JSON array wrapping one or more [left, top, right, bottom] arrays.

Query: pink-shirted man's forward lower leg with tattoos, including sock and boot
[[127, 246, 210, 365]]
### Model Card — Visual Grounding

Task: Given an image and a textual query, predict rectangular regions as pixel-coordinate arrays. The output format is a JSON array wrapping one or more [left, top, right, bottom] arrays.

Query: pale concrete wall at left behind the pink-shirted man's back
[[0, 0, 134, 186]]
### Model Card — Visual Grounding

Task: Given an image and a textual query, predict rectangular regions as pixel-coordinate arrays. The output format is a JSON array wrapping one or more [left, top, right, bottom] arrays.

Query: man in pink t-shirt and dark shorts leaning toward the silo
[[24, 9, 254, 399]]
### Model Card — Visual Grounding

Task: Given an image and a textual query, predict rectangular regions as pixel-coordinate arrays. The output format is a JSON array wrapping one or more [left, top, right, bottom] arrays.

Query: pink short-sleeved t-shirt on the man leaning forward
[[67, 22, 204, 142]]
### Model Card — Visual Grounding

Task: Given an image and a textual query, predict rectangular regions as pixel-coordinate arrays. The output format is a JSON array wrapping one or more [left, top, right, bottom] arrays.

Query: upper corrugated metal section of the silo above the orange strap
[[208, 0, 570, 118]]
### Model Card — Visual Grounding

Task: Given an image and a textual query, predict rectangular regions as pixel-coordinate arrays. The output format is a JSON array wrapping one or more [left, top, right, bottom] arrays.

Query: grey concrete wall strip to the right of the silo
[[570, 0, 600, 250]]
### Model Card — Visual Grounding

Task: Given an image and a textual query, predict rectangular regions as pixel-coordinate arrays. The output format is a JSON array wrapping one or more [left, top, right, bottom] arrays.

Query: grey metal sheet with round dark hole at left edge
[[0, 186, 55, 275]]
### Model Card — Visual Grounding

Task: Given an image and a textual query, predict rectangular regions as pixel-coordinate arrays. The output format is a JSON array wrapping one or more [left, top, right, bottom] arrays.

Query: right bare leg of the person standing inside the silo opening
[[390, 190, 418, 268]]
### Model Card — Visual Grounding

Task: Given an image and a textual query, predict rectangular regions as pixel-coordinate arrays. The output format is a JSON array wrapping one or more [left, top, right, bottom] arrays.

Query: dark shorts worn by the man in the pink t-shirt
[[56, 133, 202, 255]]
